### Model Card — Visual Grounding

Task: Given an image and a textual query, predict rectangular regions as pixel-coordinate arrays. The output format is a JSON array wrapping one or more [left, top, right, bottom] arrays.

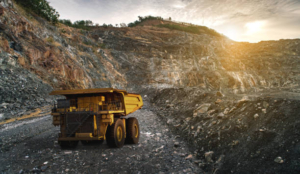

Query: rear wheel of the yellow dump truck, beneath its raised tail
[[126, 117, 140, 144]]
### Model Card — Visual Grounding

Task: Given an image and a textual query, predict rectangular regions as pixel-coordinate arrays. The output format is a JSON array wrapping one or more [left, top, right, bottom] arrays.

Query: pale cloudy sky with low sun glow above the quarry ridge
[[48, 0, 300, 42]]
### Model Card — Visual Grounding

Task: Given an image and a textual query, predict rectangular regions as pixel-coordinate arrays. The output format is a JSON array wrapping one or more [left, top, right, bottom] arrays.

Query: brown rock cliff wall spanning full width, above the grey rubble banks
[[0, 1, 300, 93]]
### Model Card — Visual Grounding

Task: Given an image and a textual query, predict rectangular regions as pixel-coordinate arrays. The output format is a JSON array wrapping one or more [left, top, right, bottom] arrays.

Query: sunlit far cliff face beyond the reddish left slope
[[92, 26, 300, 93]]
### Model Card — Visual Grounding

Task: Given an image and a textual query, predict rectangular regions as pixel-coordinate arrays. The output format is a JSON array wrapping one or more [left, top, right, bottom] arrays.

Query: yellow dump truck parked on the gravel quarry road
[[50, 88, 143, 148]]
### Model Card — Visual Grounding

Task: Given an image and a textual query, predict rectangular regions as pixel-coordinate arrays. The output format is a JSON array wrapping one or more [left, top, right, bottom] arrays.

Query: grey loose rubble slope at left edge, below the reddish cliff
[[0, 53, 54, 121]]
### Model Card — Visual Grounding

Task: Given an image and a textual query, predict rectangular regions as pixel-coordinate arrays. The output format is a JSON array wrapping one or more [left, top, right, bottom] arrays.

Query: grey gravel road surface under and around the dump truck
[[0, 101, 202, 173]]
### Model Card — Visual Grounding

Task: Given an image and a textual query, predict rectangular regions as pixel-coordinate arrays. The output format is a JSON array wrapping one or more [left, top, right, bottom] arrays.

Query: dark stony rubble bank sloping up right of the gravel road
[[151, 89, 300, 174]]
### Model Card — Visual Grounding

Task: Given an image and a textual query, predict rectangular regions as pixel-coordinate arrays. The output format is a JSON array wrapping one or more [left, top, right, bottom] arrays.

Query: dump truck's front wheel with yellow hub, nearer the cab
[[106, 119, 125, 147]]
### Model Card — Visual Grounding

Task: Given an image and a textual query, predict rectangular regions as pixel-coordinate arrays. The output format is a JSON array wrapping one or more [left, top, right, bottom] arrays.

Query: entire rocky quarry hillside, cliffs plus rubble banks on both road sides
[[0, 0, 300, 173]]
